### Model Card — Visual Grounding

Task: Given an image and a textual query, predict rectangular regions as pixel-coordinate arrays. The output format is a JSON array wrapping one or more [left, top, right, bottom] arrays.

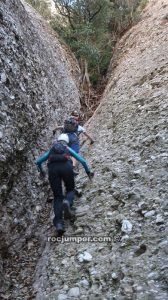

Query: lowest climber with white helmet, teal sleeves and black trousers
[[36, 133, 94, 236]]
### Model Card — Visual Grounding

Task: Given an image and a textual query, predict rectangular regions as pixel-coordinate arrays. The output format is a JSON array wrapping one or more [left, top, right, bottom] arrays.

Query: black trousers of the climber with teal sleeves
[[48, 161, 75, 226]]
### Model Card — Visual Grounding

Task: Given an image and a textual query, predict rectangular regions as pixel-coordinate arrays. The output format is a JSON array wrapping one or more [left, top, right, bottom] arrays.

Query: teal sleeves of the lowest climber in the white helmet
[[36, 146, 90, 174]]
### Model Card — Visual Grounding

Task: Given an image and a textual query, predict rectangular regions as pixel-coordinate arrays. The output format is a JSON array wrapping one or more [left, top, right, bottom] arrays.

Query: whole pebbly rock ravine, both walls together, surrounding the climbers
[[0, 0, 168, 300]]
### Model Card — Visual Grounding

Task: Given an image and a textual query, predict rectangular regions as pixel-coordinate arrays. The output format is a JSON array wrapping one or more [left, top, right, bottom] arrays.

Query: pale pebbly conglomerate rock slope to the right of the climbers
[[35, 0, 168, 300]]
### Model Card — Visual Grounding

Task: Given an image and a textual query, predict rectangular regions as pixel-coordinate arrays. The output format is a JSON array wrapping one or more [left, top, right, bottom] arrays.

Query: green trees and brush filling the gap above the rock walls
[[27, 0, 147, 115]]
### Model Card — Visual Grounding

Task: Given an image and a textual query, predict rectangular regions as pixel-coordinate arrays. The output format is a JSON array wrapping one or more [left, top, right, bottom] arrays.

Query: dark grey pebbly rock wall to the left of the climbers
[[0, 0, 80, 299]]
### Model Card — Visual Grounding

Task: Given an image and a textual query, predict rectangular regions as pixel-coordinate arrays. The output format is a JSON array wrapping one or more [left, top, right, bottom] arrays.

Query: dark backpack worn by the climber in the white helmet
[[48, 143, 70, 163]]
